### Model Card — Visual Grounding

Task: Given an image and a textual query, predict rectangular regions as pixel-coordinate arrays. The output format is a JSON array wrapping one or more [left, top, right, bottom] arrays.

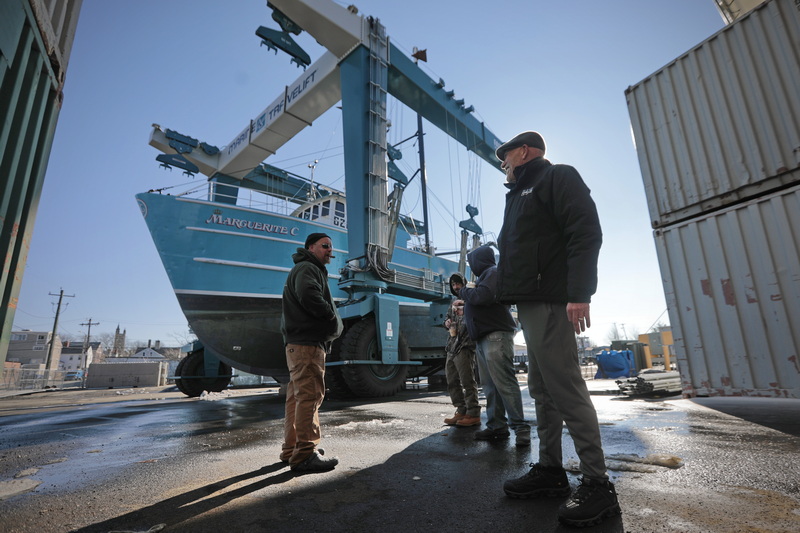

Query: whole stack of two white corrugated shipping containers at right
[[626, 0, 800, 398]]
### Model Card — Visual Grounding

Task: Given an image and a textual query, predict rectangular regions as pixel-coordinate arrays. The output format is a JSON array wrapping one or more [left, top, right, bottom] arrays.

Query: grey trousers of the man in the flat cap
[[517, 302, 608, 479]]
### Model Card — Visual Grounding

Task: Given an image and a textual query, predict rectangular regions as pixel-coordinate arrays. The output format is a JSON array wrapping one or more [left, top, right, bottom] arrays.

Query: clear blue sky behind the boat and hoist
[[14, 0, 723, 345]]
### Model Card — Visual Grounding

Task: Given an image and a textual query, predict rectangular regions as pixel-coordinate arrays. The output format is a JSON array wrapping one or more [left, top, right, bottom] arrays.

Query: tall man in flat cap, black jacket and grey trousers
[[496, 131, 620, 526]]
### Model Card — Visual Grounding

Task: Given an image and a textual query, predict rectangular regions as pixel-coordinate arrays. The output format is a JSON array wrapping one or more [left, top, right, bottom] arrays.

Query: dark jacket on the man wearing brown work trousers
[[281, 248, 342, 346]]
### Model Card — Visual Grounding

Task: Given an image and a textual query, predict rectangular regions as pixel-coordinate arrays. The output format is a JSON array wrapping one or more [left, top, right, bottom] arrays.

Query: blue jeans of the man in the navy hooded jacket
[[476, 331, 531, 433]]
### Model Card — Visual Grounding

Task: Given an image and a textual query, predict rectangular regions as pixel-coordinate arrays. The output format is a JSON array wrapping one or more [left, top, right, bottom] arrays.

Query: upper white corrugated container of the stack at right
[[625, 0, 800, 228]]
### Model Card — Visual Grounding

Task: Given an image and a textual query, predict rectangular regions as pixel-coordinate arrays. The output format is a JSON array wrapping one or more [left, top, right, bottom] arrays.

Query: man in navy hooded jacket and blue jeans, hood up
[[459, 246, 531, 447]]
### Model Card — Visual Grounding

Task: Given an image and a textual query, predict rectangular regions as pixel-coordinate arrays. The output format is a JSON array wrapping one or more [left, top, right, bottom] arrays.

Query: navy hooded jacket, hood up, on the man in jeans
[[459, 246, 517, 341]]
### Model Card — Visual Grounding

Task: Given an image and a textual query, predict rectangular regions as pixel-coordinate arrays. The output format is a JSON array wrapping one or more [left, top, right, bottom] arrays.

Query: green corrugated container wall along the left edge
[[0, 0, 83, 362]]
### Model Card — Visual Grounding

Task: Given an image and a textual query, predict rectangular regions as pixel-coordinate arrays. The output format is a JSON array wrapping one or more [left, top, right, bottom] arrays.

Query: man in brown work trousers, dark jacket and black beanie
[[281, 233, 342, 472]]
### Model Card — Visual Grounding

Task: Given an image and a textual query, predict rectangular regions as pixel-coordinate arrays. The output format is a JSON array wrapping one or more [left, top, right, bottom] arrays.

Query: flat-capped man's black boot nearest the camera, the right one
[[558, 477, 622, 527]]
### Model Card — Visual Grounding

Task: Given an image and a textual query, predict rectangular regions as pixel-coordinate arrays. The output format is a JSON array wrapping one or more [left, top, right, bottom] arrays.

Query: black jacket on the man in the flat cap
[[497, 157, 603, 304]]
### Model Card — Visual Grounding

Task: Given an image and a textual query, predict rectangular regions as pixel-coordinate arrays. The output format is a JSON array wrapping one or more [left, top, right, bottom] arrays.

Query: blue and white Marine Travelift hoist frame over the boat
[[150, 0, 501, 382]]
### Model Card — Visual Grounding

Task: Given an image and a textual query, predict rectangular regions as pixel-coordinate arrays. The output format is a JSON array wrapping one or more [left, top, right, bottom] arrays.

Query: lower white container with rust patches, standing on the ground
[[655, 181, 800, 398]]
